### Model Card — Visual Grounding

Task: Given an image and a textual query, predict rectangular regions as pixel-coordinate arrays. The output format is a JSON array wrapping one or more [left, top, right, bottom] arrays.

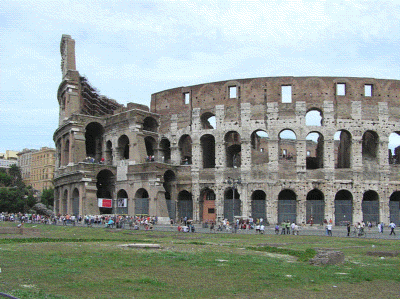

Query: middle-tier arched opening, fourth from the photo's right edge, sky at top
[[306, 132, 324, 169]]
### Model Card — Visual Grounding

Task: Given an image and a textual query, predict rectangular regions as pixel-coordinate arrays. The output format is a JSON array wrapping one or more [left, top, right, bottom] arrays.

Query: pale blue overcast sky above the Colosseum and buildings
[[0, 0, 400, 152]]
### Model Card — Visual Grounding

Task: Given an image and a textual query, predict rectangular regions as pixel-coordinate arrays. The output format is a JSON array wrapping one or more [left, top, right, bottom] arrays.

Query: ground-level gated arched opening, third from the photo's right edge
[[335, 190, 353, 226]]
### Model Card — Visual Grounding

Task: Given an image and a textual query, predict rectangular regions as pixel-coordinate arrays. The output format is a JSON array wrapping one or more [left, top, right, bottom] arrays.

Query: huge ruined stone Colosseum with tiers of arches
[[54, 35, 400, 225]]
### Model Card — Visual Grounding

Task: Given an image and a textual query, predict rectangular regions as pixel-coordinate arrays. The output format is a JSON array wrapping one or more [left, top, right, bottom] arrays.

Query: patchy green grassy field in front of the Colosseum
[[0, 223, 400, 298]]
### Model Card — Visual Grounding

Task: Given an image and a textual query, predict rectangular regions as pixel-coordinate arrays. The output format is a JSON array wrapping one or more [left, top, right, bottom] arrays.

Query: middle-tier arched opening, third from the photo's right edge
[[333, 130, 352, 168]]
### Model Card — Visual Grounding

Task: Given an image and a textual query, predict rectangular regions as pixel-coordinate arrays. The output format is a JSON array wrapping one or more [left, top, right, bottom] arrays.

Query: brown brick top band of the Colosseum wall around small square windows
[[151, 77, 400, 128]]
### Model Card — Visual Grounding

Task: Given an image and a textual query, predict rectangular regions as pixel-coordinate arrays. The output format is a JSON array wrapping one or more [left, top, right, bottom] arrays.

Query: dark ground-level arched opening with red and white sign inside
[[96, 169, 115, 214]]
